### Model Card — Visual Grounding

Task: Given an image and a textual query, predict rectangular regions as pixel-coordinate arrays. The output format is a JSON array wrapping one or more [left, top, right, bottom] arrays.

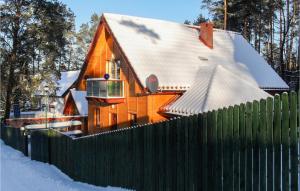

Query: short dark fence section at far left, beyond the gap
[[0, 124, 28, 156]]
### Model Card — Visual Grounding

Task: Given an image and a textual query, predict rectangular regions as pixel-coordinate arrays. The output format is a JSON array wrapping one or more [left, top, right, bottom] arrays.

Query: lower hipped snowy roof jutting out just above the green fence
[[163, 65, 271, 115]]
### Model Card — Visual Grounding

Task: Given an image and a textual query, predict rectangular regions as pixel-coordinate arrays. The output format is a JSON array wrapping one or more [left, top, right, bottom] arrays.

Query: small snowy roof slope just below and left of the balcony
[[70, 89, 88, 115]]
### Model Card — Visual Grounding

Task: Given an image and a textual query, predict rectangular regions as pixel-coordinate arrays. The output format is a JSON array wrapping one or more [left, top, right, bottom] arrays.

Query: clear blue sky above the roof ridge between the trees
[[60, 0, 207, 30]]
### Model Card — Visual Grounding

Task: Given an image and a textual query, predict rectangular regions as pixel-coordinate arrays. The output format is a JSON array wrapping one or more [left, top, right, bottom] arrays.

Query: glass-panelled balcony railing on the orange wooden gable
[[87, 78, 124, 99]]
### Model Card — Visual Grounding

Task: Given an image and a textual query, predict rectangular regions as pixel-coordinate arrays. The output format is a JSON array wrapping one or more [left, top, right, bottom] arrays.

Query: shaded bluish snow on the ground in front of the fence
[[0, 140, 124, 191]]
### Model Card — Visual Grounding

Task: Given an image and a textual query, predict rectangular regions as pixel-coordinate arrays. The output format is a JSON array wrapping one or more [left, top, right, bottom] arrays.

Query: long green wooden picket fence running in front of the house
[[32, 92, 300, 191]]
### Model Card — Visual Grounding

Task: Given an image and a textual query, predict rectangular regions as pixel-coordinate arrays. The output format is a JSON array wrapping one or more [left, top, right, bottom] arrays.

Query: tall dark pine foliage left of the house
[[0, 0, 74, 119]]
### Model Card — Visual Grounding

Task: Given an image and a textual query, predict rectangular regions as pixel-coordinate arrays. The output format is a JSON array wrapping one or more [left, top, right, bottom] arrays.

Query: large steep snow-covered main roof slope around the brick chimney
[[103, 13, 288, 90]]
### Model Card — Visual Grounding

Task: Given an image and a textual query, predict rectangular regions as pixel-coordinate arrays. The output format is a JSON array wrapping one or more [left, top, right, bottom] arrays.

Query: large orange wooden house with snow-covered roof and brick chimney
[[65, 13, 289, 133]]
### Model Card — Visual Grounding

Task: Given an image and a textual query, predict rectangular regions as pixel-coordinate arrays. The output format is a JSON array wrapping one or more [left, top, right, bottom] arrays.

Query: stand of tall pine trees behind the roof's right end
[[202, 0, 300, 86]]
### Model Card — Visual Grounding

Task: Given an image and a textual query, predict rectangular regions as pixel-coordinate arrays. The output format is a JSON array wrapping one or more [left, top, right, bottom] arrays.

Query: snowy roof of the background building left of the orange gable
[[56, 70, 80, 96]]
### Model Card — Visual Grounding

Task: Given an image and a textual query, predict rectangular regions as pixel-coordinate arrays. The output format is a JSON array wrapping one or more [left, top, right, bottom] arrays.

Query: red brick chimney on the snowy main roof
[[199, 23, 213, 49]]
